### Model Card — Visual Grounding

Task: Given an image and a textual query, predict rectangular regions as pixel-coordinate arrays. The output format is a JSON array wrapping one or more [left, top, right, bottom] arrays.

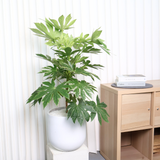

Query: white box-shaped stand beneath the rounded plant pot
[[47, 144, 89, 160]]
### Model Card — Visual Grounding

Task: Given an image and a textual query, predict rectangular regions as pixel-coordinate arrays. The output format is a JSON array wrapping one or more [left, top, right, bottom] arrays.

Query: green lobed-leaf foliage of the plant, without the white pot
[[27, 14, 109, 125]]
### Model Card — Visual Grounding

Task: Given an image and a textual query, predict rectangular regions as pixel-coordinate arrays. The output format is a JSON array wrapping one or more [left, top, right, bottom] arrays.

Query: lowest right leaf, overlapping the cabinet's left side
[[86, 96, 109, 124]]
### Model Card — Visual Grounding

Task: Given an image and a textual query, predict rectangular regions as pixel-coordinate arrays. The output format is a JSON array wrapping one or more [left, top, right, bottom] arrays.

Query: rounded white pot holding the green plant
[[47, 107, 86, 151]]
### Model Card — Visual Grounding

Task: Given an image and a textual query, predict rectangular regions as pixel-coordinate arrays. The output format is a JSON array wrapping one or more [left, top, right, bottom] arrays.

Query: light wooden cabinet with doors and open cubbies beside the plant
[[100, 80, 160, 160]]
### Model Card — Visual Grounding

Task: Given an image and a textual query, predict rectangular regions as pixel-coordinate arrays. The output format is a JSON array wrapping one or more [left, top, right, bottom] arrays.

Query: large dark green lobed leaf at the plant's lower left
[[27, 80, 69, 108]]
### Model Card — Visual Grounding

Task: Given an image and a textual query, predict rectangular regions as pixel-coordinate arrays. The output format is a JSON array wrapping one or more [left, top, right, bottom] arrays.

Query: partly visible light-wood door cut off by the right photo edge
[[154, 92, 160, 125]]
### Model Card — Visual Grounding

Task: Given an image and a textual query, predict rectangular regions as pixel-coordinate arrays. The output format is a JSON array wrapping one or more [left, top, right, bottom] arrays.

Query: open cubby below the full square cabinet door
[[121, 129, 152, 160]]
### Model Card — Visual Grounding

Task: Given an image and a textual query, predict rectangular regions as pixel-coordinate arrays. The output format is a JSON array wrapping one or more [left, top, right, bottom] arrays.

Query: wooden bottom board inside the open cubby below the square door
[[121, 146, 149, 160]]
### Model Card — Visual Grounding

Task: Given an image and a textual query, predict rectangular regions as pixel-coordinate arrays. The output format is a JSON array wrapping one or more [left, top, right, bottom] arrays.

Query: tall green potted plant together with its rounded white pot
[[27, 14, 109, 151]]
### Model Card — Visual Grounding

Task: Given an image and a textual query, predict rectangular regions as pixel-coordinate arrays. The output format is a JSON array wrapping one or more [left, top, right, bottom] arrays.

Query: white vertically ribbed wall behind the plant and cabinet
[[0, 0, 160, 160]]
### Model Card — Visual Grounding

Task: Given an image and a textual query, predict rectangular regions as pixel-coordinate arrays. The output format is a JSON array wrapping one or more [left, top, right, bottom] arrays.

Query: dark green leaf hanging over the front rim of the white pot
[[67, 99, 96, 125]]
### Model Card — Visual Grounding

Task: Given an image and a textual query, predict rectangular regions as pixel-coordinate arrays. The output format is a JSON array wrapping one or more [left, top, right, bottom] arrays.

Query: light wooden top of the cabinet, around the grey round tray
[[101, 80, 160, 94]]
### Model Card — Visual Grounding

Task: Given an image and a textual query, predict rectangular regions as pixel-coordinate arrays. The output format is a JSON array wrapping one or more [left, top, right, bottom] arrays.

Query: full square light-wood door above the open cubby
[[121, 93, 151, 130]]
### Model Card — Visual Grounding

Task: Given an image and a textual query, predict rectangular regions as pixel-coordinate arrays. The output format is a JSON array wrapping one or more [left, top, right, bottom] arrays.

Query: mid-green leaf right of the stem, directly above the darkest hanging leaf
[[67, 79, 96, 100]]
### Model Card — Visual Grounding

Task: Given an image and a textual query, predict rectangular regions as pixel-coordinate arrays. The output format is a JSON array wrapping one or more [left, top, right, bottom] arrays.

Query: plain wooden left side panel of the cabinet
[[100, 89, 120, 160]]
